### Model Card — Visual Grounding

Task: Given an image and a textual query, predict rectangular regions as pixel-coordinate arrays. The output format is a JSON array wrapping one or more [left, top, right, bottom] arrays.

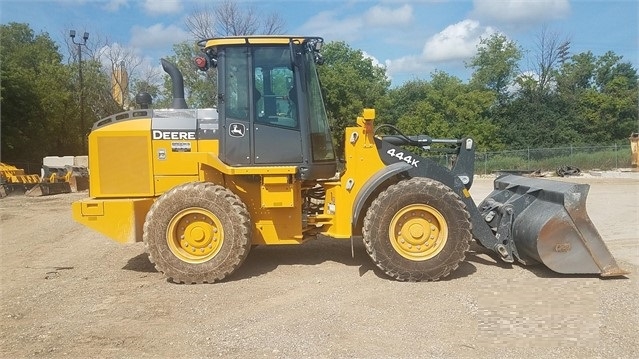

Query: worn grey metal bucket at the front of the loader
[[479, 175, 629, 277]]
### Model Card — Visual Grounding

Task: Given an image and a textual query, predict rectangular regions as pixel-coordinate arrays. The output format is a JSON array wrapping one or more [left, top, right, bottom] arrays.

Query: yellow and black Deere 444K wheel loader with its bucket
[[73, 36, 627, 283]]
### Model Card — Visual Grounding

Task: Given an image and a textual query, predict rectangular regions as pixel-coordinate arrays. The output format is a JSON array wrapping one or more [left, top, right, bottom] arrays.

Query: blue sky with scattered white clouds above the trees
[[0, 0, 639, 85]]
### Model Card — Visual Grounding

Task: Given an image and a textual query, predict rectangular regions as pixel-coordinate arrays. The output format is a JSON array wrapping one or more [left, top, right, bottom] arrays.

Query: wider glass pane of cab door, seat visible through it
[[253, 47, 299, 128]]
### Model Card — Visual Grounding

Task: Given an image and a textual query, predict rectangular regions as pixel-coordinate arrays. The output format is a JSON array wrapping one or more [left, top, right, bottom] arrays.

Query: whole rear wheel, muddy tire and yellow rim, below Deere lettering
[[143, 182, 251, 283]]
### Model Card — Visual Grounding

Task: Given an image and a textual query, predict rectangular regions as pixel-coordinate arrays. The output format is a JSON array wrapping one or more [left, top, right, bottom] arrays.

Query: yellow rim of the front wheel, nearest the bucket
[[388, 204, 448, 261]]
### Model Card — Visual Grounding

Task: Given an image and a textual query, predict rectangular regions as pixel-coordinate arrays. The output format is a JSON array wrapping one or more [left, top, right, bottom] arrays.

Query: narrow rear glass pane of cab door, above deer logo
[[224, 47, 249, 121]]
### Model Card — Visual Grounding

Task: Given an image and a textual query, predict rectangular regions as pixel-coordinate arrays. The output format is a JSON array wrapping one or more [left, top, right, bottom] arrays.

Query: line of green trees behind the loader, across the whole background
[[0, 1, 639, 167]]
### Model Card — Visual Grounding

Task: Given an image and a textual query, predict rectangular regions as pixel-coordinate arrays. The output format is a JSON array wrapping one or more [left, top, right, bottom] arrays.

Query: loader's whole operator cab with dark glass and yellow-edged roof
[[196, 36, 337, 180]]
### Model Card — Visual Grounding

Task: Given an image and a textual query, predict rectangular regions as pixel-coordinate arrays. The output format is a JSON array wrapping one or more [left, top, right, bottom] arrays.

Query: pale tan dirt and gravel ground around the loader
[[0, 173, 639, 359]]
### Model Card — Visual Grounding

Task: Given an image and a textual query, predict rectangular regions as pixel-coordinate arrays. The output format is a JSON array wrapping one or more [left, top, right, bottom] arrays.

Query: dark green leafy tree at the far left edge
[[0, 23, 83, 163]]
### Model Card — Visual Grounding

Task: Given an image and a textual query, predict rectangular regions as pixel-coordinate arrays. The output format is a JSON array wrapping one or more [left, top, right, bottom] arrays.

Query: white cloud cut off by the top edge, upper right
[[473, 0, 570, 25]]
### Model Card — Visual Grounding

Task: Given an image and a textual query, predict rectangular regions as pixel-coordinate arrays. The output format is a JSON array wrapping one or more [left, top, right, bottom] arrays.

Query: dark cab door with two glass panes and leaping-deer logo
[[218, 44, 304, 166]]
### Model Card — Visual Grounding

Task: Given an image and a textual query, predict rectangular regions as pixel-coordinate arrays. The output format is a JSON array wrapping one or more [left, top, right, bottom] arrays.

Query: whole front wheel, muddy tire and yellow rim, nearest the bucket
[[362, 177, 472, 282]]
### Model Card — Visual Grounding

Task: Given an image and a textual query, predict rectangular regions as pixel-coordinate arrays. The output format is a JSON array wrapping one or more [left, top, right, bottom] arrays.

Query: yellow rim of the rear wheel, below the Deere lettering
[[166, 208, 224, 263]]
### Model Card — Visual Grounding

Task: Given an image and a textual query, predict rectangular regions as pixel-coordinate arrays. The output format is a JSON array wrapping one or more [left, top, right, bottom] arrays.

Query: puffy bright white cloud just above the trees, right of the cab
[[422, 19, 496, 62]]
